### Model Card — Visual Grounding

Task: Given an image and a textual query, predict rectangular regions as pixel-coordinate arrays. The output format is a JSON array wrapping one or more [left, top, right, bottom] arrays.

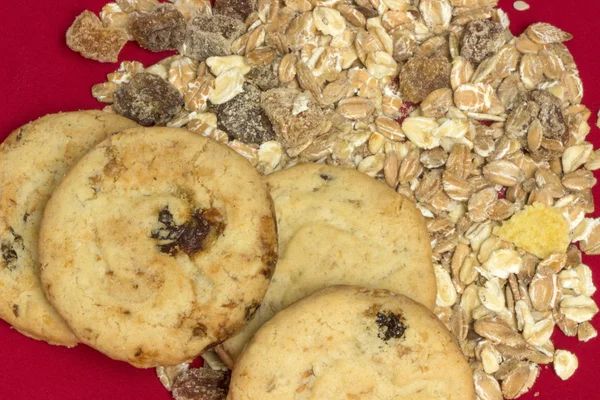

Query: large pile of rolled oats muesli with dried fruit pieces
[[69, 0, 600, 399]]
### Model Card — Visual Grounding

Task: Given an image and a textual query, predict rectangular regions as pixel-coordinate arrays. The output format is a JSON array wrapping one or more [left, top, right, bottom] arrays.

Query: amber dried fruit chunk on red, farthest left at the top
[[67, 10, 129, 62]]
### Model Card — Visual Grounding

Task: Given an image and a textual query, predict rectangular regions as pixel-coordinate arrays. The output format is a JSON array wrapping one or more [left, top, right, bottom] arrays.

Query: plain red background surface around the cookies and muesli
[[0, 0, 600, 400]]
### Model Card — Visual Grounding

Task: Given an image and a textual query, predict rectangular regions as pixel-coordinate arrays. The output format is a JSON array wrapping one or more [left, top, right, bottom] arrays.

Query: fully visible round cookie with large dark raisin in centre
[[40, 128, 277, 367]]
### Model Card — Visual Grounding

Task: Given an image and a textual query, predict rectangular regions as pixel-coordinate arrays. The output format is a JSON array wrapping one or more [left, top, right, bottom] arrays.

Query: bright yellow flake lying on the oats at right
[[494, 203, 570, 258]]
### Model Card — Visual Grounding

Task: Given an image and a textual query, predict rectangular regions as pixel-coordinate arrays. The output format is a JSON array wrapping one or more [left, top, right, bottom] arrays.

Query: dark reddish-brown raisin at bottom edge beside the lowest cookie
[[172, 368, 231, 400]]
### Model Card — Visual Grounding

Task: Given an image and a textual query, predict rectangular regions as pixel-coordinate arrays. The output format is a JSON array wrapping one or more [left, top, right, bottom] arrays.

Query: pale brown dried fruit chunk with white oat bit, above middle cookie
[[261, 88, 331, 148]]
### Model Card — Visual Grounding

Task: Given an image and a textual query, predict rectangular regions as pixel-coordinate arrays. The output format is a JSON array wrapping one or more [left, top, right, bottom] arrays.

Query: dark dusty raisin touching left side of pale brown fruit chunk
[[216, 83, 275, 144]]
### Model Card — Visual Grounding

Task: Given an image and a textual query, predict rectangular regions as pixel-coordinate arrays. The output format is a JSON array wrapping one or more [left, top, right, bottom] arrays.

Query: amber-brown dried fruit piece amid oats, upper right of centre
[[399, 56, 452, 103]]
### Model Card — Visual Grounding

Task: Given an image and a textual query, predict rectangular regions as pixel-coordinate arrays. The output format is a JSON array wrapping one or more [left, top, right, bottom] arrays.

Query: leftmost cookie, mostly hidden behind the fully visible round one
[[0, 111, 137, 346]]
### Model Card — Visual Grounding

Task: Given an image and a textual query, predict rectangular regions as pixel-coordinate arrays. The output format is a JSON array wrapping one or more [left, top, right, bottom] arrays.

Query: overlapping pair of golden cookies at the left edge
[[0, 112, 277, 367]]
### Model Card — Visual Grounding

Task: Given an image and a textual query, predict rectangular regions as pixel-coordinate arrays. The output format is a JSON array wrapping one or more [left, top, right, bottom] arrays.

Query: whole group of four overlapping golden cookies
[[0, 111, 474, 400]]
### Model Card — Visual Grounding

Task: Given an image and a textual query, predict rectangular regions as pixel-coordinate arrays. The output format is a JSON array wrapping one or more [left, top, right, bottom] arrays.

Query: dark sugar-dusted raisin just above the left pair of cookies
[[113, 73, 183, 126]]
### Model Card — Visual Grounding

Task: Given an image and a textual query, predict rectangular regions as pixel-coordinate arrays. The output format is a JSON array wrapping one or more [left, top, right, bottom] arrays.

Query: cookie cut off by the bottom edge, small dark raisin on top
[[227, 286, 475, 400]]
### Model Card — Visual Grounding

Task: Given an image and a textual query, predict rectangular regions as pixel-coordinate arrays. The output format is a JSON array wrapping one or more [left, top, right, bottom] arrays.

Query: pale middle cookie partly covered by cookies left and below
[[217, 164, 436, 367]]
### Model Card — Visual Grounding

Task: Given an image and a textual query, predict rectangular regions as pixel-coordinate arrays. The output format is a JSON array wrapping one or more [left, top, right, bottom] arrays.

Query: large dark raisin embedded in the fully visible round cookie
[[150, 207, 225, 257]]
